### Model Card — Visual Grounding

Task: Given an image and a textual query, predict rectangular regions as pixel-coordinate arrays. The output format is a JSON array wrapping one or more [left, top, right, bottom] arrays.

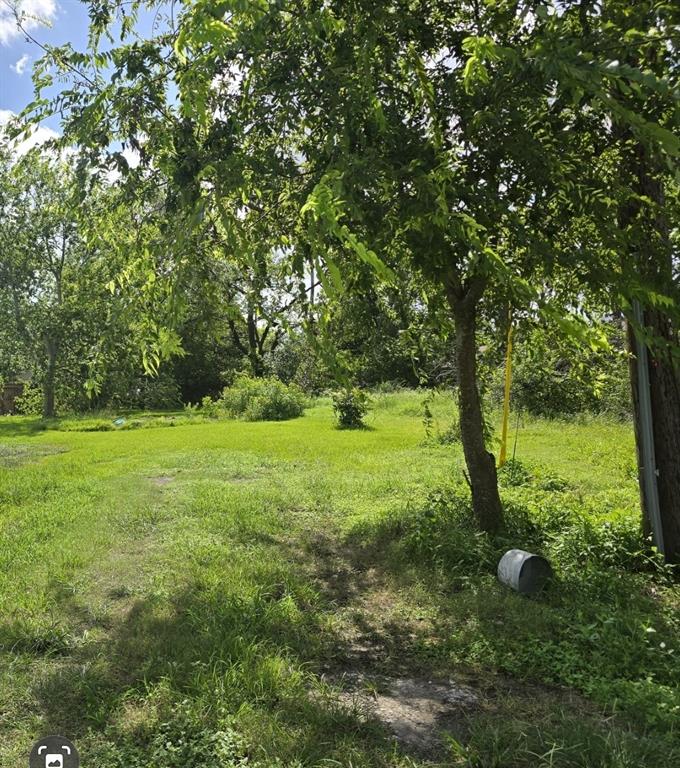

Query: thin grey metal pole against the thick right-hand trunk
[[633, 300, 666, 555]]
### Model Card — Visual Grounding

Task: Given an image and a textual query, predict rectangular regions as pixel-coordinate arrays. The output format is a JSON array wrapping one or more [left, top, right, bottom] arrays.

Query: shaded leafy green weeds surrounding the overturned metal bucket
[[378, 476, 680, 732]]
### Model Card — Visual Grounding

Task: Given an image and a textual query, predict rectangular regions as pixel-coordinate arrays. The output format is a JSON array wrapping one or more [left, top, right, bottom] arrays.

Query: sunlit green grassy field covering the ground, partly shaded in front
[[0, 392, 680, 768]]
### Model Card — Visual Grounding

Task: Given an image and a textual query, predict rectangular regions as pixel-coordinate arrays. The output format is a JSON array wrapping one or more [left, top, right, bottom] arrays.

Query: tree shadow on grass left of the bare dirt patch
[[33, 572, 404, 766]]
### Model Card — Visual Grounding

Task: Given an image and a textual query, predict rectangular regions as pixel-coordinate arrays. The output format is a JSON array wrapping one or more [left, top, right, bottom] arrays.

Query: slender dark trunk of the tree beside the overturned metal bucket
[[452, 303, 503, 533]]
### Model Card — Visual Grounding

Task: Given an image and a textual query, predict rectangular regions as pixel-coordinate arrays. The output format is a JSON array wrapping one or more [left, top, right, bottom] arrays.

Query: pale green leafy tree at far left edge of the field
[[0, 145, 158, 418]]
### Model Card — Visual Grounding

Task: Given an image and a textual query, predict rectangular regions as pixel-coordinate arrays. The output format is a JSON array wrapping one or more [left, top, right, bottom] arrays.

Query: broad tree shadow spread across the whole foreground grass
[[18, 476, 680, 768]]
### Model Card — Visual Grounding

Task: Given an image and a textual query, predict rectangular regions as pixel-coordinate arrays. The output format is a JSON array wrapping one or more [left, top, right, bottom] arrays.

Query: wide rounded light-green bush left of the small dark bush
[[217, 374, 305, 421]]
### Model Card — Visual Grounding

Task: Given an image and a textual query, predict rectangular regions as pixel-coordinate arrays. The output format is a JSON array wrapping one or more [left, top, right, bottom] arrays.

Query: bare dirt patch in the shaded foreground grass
[[301, 536, 587, 761]]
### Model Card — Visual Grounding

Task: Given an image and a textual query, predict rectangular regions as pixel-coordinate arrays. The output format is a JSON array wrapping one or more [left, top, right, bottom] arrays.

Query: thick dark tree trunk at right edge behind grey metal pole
[[620, 145, 680, 563]]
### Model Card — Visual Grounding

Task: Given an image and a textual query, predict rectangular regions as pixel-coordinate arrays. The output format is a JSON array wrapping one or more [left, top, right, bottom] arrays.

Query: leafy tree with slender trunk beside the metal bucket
[[29, 0, 680, 531]]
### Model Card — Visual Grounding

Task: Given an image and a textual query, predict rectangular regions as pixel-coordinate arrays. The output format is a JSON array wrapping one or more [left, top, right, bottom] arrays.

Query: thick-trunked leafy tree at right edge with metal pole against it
[[504, 0, 680, 562]]
